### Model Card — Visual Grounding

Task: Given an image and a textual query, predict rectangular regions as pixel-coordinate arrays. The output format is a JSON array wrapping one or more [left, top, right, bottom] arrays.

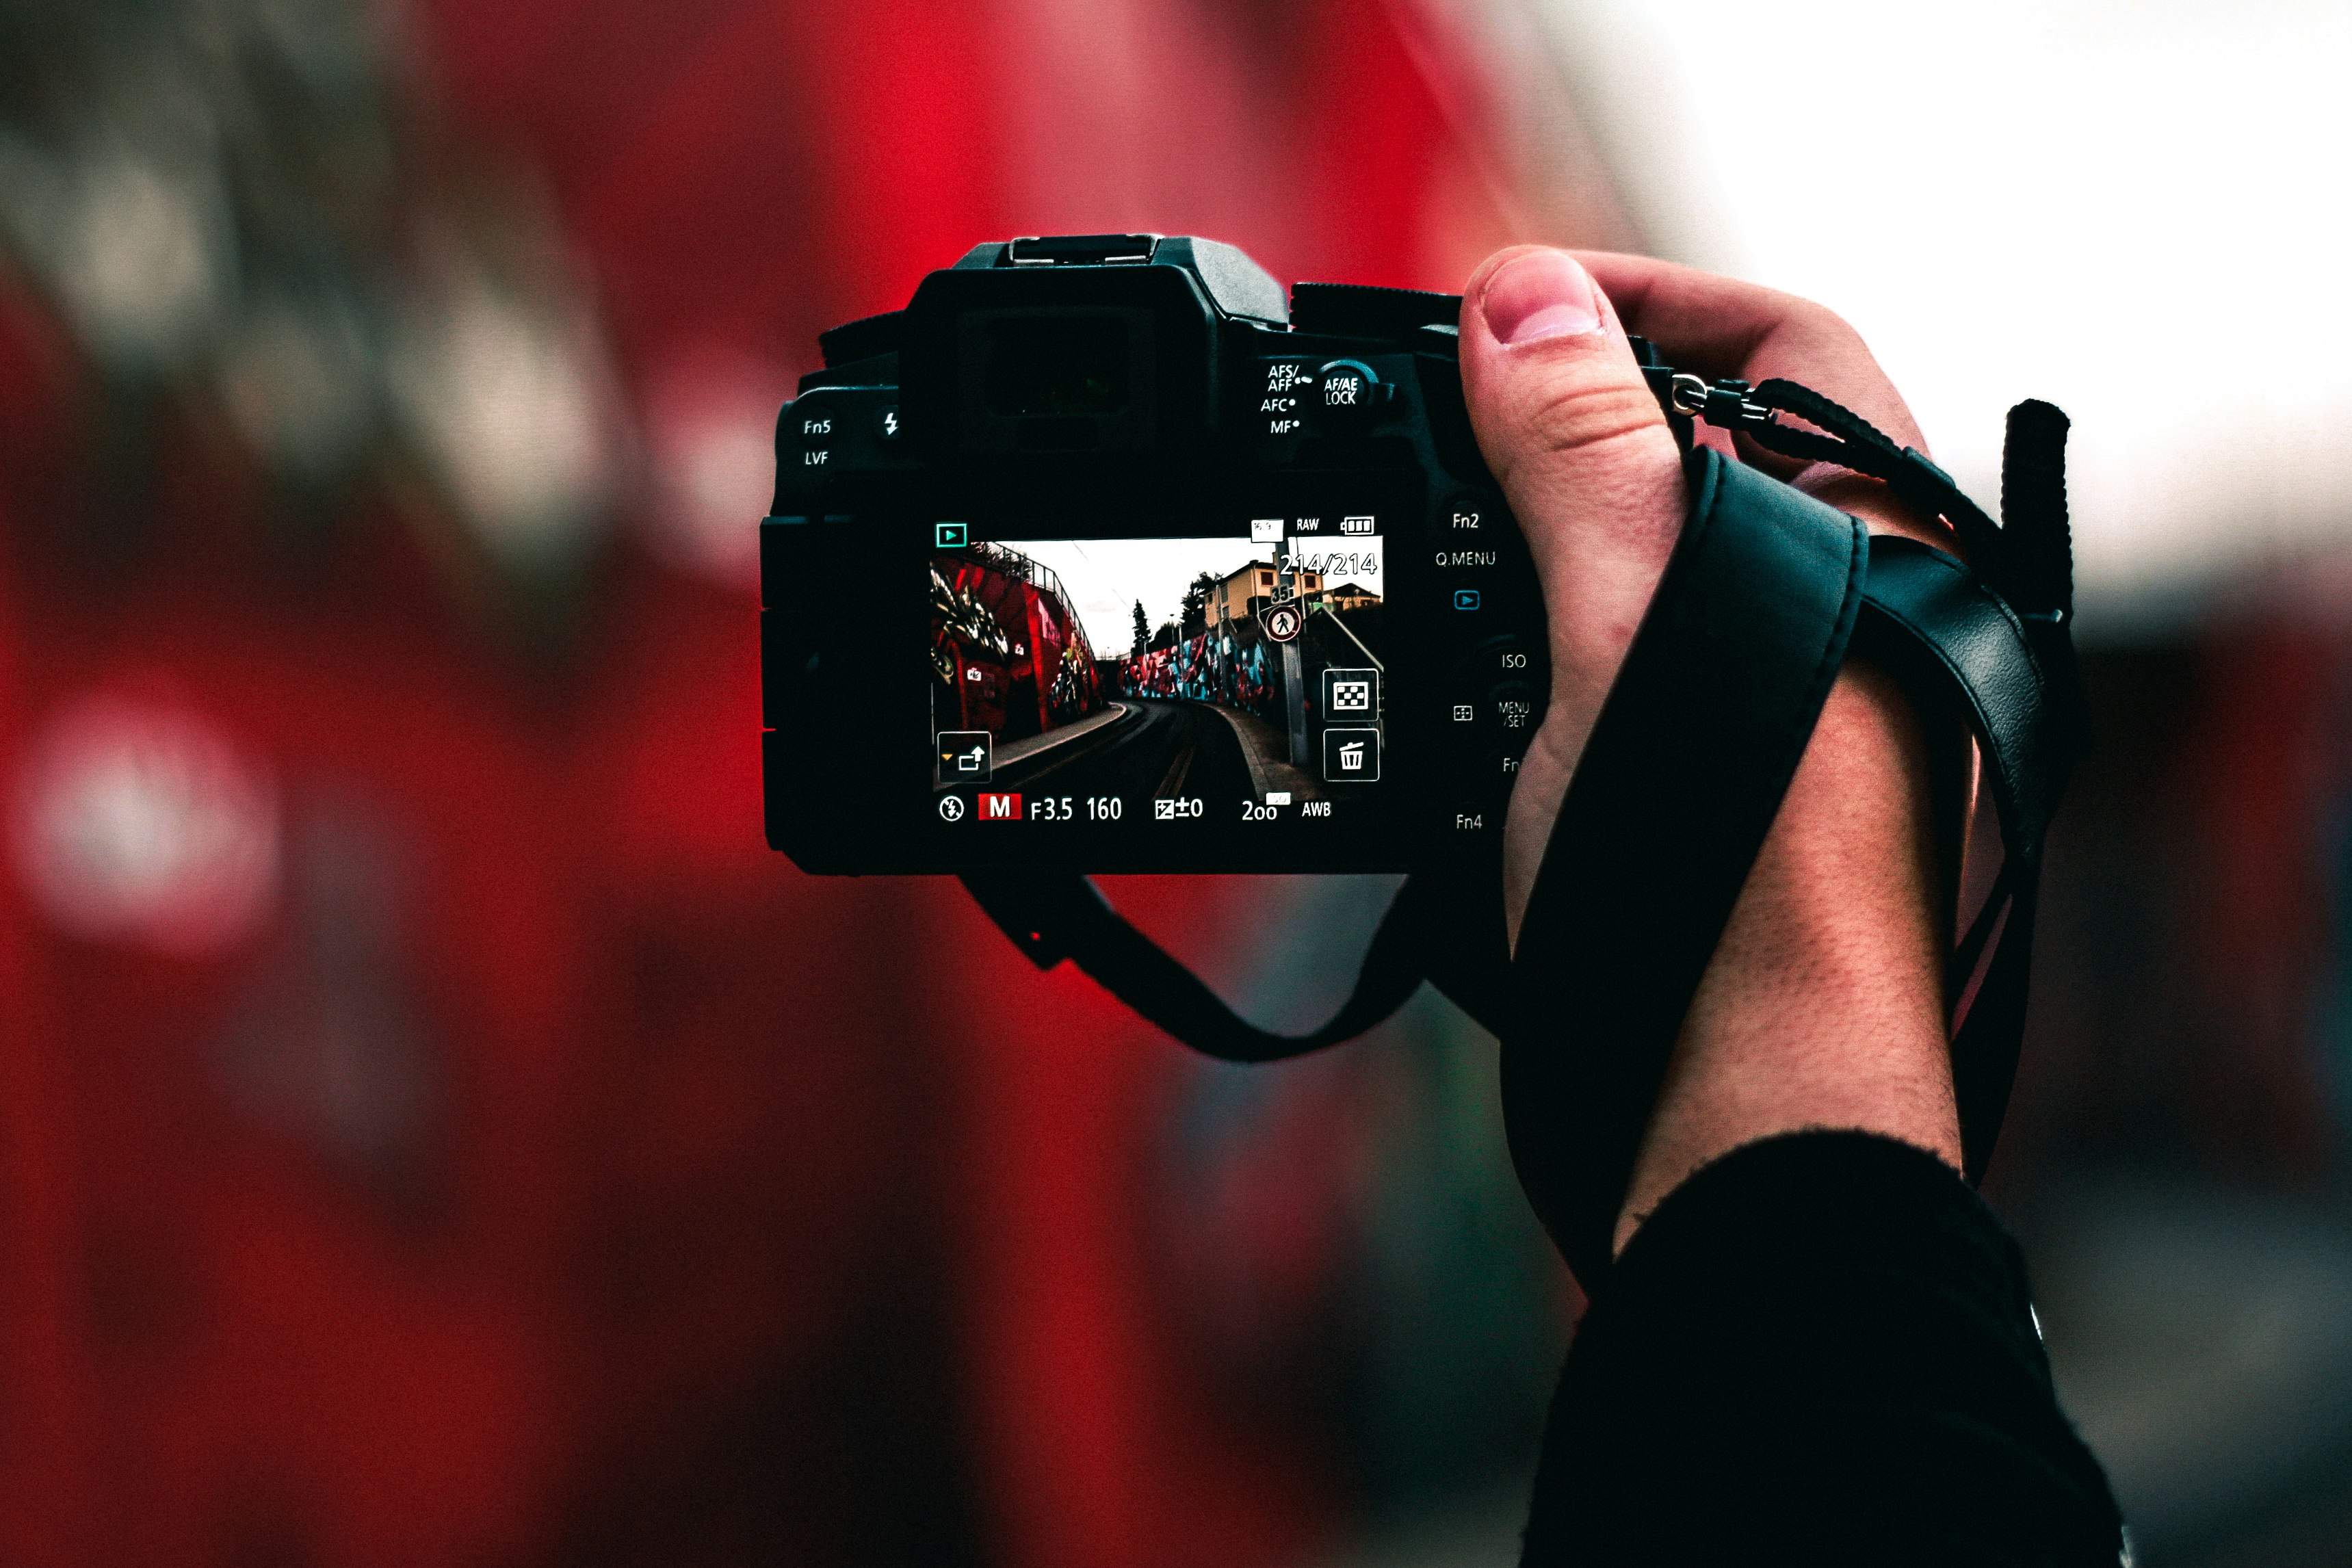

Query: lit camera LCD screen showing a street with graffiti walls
[[929, 515, 1392, 835]]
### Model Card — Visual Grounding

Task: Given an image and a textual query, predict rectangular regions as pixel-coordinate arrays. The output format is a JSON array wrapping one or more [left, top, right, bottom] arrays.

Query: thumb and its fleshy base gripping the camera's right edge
[[1461, 247, 1684, 941]]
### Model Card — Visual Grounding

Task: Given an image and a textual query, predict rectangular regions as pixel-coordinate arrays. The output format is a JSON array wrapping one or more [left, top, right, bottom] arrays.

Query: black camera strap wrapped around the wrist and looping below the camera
[[965, 367, 2082, 1283]]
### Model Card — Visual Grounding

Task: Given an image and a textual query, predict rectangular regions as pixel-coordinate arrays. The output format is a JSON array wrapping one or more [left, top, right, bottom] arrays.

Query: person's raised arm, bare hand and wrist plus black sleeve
[[1461, 249, 2119, 1566]]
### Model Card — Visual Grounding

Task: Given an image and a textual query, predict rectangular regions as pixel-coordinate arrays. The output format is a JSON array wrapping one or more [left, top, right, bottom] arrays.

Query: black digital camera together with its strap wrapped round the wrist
[[759, 235, 2084, 1316]]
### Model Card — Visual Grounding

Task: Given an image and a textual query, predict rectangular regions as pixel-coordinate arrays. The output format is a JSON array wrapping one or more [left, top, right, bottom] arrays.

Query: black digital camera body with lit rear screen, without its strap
[[759, 235, 1550, 874]]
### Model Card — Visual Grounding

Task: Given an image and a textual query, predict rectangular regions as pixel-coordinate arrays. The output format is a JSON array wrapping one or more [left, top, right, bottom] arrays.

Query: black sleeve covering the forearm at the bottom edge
[[1521, 1133, 2128, 1568]]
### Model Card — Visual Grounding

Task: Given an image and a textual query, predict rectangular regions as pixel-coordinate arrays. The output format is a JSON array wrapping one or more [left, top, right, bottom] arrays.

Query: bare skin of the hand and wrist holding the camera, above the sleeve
[[1461, 247, 1959, 1244]]
